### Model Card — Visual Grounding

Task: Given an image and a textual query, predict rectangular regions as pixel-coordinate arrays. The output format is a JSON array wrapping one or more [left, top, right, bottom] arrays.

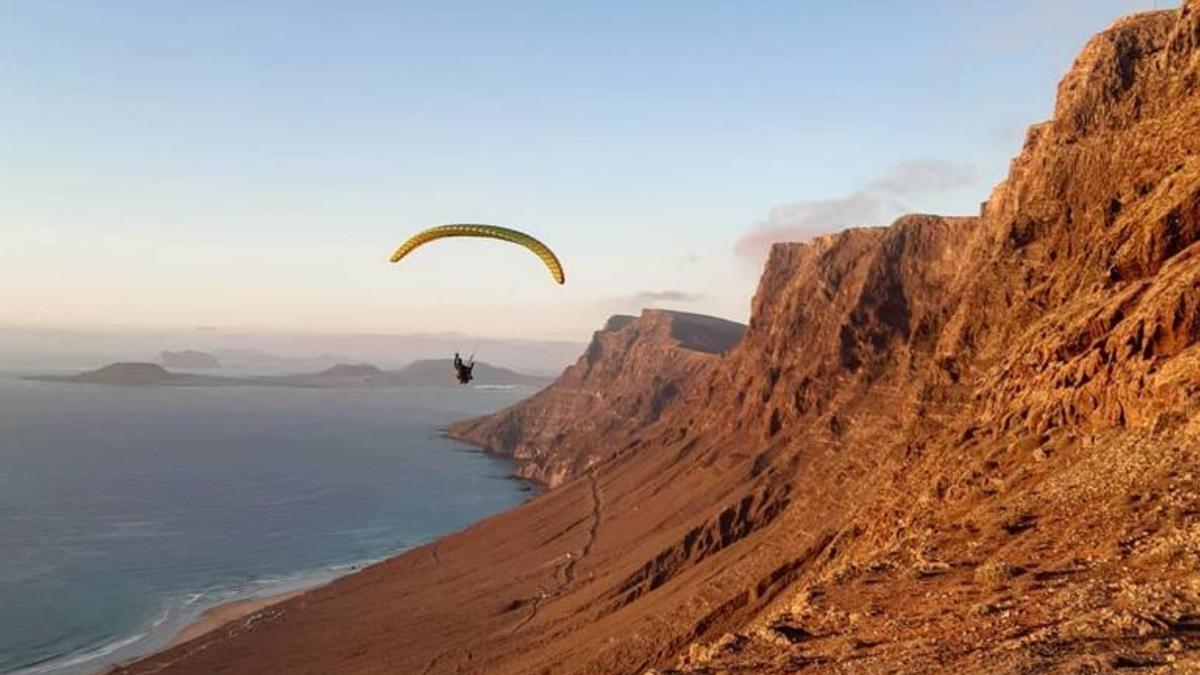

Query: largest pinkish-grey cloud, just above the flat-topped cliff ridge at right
[[733, 160, 977, 261]]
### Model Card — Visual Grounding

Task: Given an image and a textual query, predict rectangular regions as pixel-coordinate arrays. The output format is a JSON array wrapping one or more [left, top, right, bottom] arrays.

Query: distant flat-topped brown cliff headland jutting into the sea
[[450, 310, 745, 486]]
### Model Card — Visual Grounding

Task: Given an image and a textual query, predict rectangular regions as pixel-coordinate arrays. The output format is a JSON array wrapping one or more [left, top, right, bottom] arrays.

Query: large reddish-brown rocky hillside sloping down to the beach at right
[[117, 0, 1200, 675]]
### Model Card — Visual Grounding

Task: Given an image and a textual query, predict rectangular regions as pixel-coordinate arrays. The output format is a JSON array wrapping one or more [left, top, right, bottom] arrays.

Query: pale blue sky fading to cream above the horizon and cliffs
[[0, 0, 1161, 340]]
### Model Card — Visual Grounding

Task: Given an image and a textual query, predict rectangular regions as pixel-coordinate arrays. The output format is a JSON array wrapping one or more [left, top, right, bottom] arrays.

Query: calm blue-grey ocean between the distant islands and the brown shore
[[0, 375, 530, 674]]
